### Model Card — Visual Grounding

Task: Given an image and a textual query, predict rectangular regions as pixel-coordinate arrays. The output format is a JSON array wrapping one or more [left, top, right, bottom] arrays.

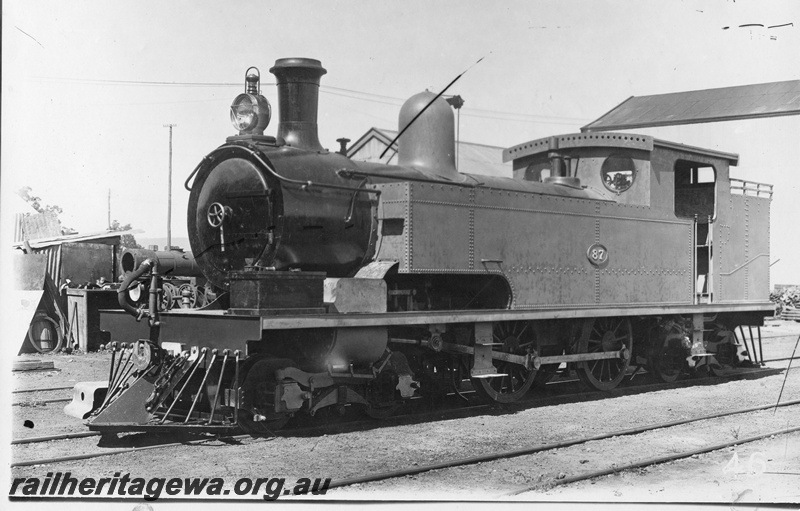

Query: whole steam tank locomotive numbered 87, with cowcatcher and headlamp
[[70, 58, 772, 433]]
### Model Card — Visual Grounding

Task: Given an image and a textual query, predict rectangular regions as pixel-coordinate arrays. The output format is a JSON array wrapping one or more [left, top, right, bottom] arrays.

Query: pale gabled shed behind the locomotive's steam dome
[[347, 128, 512, 177]]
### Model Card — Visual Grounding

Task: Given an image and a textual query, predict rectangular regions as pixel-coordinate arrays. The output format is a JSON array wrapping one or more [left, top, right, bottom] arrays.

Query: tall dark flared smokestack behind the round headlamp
[[269, 58, 327, 151]]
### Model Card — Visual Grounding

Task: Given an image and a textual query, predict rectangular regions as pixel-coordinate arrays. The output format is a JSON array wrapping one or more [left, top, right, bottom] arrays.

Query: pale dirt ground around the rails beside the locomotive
[[11, 321, 800, 504]]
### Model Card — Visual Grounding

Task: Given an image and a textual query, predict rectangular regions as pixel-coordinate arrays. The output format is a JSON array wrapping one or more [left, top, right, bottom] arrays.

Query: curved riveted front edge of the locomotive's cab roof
[[503, 133, 654, 163]]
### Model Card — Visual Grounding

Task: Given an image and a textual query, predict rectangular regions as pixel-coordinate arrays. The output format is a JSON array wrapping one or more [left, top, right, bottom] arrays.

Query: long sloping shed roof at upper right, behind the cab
[[581, 80, 800, 132]]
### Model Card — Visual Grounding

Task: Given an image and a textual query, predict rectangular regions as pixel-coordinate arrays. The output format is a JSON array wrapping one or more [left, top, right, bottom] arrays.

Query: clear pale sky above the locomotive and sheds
[[2, 0, 800, 283]]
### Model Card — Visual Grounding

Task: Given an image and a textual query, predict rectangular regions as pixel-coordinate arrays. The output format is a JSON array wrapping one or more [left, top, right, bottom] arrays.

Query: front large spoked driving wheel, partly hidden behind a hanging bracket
[[471, 321, 537, 403]]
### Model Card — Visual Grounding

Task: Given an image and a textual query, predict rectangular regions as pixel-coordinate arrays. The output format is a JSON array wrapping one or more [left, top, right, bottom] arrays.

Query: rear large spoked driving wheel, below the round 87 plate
[[576, 318, 633, 390]]
